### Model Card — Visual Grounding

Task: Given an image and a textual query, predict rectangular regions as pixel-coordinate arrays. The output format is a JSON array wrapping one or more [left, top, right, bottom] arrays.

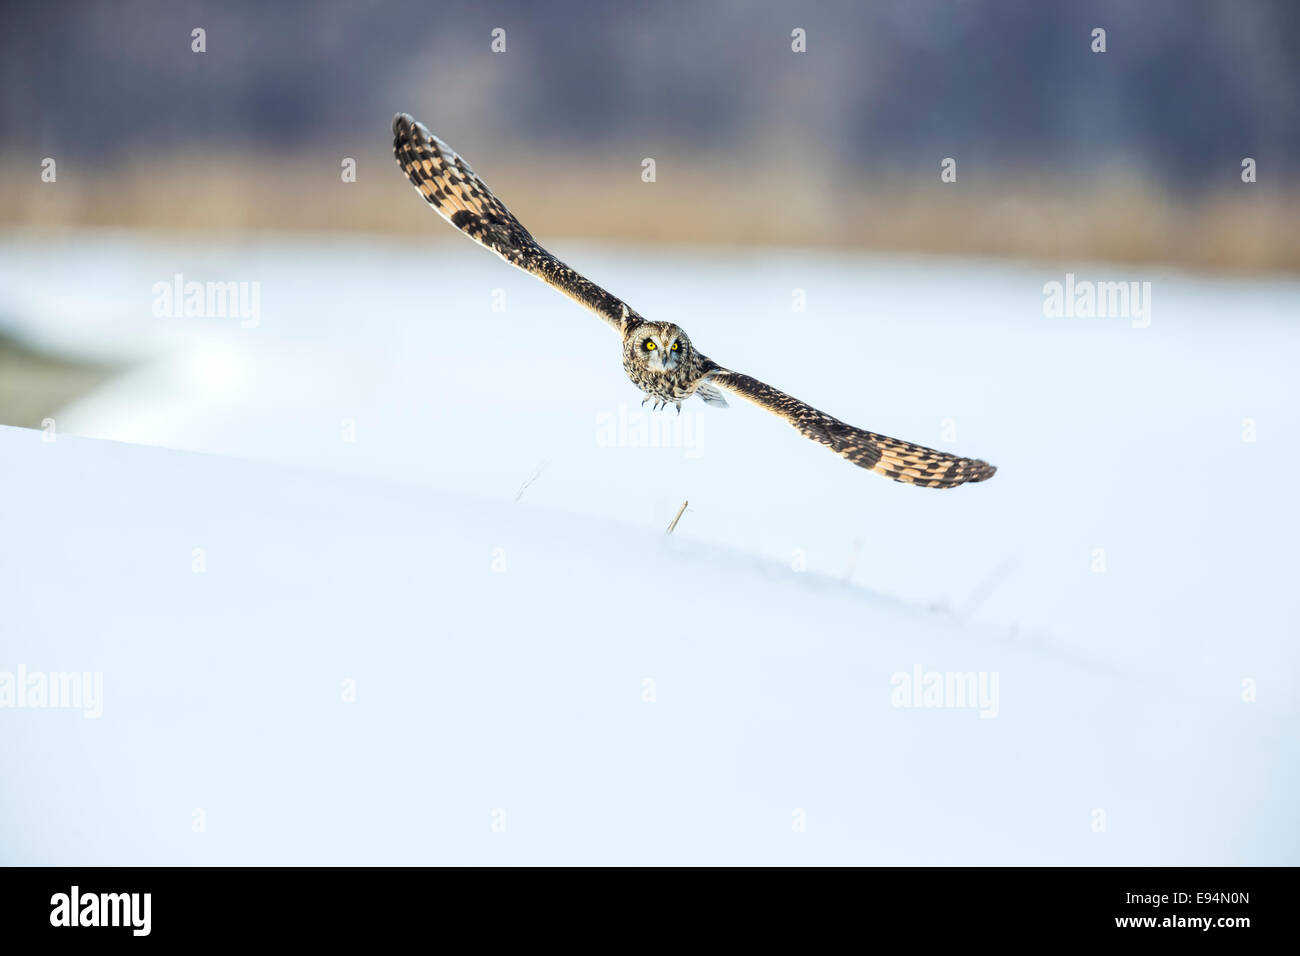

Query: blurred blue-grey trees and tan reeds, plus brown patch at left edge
[[0, 0, 1300, 425]]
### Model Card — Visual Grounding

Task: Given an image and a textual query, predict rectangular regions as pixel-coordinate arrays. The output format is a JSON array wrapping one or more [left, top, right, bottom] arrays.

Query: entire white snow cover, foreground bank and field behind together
[[0, 234, 1300, 864]]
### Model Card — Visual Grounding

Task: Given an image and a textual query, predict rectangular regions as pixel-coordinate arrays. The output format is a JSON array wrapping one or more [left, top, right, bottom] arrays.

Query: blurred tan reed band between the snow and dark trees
[[0, 150, 1300, 272]]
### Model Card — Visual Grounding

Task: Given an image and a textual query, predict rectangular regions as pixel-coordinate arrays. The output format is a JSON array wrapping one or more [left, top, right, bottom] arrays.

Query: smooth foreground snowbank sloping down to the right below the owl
[[0, 428, 1300, 864]]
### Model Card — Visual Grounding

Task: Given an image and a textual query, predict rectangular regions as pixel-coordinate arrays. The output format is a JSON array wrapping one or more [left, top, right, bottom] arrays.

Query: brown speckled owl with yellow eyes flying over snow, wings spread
[[393, 113, 997, 488]]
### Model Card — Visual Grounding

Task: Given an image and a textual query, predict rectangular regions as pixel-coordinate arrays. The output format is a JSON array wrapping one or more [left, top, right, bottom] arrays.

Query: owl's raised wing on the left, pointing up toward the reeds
[[393, 113, 640, 333]]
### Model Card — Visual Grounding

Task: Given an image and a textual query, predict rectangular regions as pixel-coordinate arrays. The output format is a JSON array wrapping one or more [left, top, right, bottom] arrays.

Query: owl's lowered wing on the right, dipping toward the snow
[[709, 368, 997, 488]]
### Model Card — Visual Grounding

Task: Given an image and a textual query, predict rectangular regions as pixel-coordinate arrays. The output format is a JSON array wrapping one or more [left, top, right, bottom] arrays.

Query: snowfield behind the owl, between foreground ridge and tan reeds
[[0, 231, 1300, 671]]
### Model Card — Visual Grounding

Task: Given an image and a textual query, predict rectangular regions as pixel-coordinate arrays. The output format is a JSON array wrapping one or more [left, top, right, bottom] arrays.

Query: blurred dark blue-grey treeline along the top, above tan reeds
[[0, 0, 1300, 191]]
